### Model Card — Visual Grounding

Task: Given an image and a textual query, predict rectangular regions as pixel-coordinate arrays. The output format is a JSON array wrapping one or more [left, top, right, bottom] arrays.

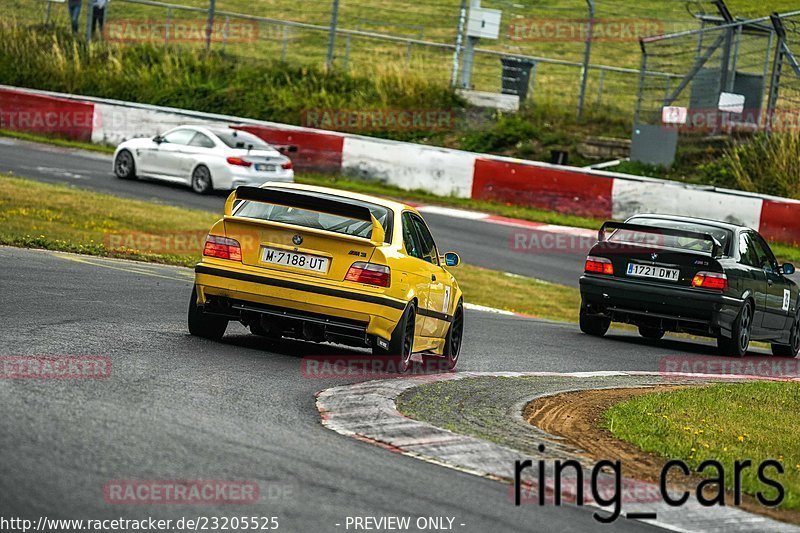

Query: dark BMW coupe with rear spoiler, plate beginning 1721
[[580, 215, 800, 357]]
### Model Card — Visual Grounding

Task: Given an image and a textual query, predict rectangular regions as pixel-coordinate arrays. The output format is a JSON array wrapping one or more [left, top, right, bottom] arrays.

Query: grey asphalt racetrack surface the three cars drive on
[[0, 136, 780, 532]]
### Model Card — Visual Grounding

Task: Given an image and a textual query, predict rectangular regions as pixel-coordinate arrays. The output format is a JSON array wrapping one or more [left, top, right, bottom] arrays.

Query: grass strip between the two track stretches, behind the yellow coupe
[[0, 176, 579, 321]]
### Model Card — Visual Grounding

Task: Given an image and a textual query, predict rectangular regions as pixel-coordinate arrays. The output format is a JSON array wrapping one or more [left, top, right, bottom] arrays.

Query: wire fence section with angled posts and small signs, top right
[[634, 8, 800, 133]]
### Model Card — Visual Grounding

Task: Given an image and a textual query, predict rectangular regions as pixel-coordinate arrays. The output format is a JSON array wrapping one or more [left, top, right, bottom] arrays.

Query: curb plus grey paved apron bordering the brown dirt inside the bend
[[317, 372, 800, 532]]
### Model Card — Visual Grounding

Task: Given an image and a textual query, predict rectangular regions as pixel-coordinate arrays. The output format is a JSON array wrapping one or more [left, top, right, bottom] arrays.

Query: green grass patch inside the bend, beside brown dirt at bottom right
[[603, 382, 800, 510]]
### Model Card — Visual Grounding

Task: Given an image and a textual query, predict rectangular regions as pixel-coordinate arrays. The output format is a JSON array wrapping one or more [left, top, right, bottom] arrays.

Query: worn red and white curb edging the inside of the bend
[[317, 372, 800, 533]]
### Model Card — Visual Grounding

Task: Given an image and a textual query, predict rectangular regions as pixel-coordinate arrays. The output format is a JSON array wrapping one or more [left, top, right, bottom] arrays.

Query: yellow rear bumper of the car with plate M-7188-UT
[[195, 263, 406, 341]]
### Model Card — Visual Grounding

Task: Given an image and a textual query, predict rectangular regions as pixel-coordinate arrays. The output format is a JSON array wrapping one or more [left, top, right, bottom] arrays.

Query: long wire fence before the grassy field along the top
[[23, 0, 724, 115]]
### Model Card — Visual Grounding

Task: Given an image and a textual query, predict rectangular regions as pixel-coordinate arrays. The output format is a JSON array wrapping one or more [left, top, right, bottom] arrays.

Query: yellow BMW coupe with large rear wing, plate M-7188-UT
[[189, 183, 464, 371]]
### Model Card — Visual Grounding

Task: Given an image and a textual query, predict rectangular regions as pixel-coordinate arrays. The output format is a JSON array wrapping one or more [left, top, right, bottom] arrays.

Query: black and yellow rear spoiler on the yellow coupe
[[225, 186, 386, 246]]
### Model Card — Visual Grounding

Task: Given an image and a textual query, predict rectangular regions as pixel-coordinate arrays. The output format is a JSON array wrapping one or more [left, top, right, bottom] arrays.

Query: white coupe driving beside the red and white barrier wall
[[114, 126, 294, 194]]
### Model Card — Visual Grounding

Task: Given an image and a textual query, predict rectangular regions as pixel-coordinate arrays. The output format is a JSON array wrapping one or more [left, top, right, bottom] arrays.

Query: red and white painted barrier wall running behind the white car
[[0, 86, 800, 242]]
